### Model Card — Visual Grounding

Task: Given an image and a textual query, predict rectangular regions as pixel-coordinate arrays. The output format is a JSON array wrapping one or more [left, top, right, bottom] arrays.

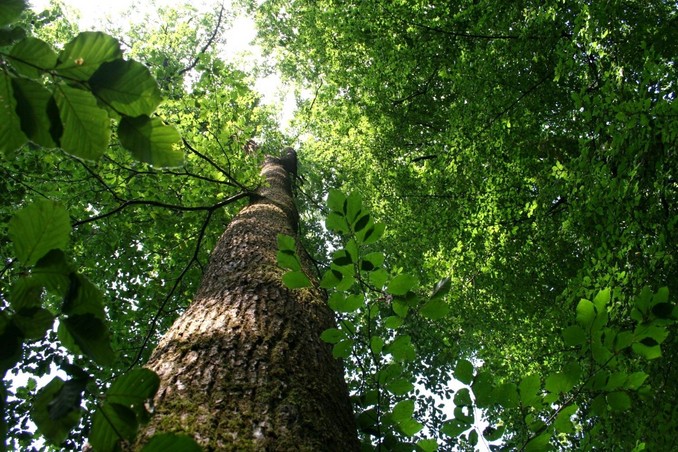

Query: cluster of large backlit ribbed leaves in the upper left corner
[[0, 24, 183, 167]]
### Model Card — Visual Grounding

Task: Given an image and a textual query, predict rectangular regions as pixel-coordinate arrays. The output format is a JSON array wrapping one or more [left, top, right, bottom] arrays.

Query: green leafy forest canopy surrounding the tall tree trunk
[[0, 0, 678, 451]]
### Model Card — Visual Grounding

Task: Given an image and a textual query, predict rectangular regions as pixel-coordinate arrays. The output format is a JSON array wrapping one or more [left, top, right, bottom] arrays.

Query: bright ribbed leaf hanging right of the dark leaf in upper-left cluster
[[54, 85, 111, 160]]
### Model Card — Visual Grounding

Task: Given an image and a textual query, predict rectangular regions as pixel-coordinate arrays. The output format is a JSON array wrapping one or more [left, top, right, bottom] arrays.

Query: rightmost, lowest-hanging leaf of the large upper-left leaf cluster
[[118, 116, 184, 167]]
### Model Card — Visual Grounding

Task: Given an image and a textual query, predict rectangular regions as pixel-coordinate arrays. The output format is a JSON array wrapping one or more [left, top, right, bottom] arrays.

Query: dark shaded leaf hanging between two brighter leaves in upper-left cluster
[[12, 78, 61, 148]]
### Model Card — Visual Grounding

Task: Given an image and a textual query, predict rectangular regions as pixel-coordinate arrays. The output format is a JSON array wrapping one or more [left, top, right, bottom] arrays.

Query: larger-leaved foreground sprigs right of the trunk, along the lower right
[[278, 190, 678, 450]]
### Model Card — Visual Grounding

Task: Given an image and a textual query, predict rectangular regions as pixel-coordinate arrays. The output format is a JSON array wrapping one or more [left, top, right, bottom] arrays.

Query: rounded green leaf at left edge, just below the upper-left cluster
[[8, 200, 71, 266]]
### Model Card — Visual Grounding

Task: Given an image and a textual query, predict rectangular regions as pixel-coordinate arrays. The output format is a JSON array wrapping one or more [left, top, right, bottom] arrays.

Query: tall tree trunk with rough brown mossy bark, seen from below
[[141, 149, 359, 451]]
